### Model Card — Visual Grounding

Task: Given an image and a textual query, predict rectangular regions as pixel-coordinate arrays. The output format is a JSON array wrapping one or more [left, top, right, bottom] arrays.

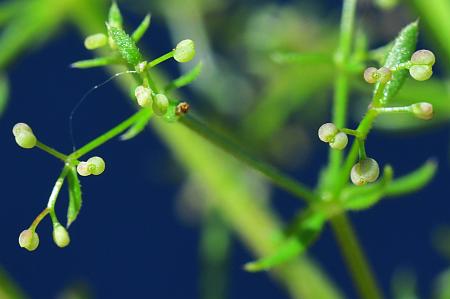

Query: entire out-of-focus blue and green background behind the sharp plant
[[0, 0, 450, 299]]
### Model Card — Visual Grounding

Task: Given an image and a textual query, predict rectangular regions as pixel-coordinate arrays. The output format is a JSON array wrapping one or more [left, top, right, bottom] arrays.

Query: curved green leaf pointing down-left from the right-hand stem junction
[[244, 210, 326, 272]]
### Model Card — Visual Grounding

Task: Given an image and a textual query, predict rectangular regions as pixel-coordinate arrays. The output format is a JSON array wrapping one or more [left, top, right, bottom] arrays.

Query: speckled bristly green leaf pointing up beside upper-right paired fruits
[[378, 21, 419, 104]]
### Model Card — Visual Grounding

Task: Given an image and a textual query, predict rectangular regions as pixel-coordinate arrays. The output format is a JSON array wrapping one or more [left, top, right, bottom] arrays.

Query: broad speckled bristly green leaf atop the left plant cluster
[[107, 24, 142, 66]]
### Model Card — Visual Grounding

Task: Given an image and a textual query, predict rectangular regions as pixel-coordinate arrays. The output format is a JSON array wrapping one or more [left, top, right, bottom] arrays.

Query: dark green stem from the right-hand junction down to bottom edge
[[330, 213, 383, 299]]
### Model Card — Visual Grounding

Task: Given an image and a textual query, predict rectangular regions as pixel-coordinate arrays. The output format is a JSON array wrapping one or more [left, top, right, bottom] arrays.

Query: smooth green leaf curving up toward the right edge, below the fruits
[[386, 160, 437, 196]]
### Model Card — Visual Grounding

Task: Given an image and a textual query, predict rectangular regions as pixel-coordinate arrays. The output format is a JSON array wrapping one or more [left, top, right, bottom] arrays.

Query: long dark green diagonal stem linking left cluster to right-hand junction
[[180, 114, 316, 202]]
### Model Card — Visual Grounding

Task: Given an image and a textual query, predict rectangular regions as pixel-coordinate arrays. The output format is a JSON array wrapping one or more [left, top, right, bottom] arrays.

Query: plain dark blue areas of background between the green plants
[[0, 0, 450, 299]]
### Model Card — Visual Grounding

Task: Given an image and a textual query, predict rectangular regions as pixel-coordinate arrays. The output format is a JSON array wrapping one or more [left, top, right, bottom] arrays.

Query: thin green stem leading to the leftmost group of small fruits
[[68, 109, 147, 159]]
